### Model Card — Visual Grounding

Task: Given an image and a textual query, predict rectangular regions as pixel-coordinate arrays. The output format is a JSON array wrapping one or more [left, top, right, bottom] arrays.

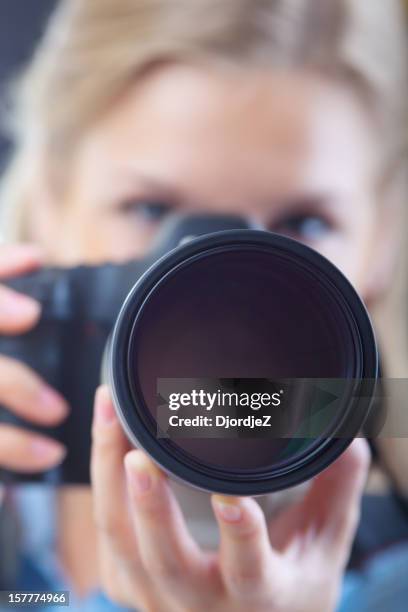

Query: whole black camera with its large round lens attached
[[0, 215, 378, 495]]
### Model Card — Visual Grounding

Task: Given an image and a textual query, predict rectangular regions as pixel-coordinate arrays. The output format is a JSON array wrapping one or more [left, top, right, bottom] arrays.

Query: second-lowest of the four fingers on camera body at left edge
[[0, 357, 69, 425]]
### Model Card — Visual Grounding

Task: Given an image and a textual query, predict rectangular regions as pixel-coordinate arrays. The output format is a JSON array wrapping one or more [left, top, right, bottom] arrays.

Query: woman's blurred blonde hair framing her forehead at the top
[[0, 0, 408, 239]]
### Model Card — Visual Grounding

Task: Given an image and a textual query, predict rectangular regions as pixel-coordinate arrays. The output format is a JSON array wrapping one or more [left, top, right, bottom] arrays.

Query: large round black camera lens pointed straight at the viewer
[[105, 229, 378, 495]]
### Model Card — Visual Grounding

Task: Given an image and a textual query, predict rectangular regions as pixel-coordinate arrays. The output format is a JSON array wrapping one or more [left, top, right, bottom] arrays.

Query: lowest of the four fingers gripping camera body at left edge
[[0, 425, 66, 473]]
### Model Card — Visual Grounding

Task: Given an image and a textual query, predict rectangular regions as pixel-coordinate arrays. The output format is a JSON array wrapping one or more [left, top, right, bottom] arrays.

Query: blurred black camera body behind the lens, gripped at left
[[0, 215, 253, 484]]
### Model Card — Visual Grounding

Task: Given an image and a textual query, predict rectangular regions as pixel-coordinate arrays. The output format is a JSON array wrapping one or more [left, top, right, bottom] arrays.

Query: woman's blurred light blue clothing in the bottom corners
[[0, 486, 408, 612]]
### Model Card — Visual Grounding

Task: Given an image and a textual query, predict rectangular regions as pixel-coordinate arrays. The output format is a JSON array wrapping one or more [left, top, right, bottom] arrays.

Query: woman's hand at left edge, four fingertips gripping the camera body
[[0, 245, 68, 473]]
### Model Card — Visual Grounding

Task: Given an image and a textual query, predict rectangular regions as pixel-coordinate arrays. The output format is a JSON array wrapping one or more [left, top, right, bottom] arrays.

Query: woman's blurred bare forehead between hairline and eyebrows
[[76, 65, 376, 204]]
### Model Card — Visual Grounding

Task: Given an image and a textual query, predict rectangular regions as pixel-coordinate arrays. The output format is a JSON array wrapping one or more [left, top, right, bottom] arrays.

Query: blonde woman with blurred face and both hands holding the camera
[[0, 0, 408, 612]]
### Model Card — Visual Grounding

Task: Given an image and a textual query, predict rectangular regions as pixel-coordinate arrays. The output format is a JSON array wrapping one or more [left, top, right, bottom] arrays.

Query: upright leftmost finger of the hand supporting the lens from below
[[91, 386, 136, 558]]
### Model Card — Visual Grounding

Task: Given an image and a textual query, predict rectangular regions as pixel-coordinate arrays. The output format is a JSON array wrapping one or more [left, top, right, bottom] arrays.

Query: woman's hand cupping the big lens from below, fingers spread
[[92, 387, 369, 612]]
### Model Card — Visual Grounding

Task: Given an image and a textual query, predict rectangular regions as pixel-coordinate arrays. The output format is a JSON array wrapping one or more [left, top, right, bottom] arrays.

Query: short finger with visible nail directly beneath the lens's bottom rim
[[212, 495, 280, 599]]
